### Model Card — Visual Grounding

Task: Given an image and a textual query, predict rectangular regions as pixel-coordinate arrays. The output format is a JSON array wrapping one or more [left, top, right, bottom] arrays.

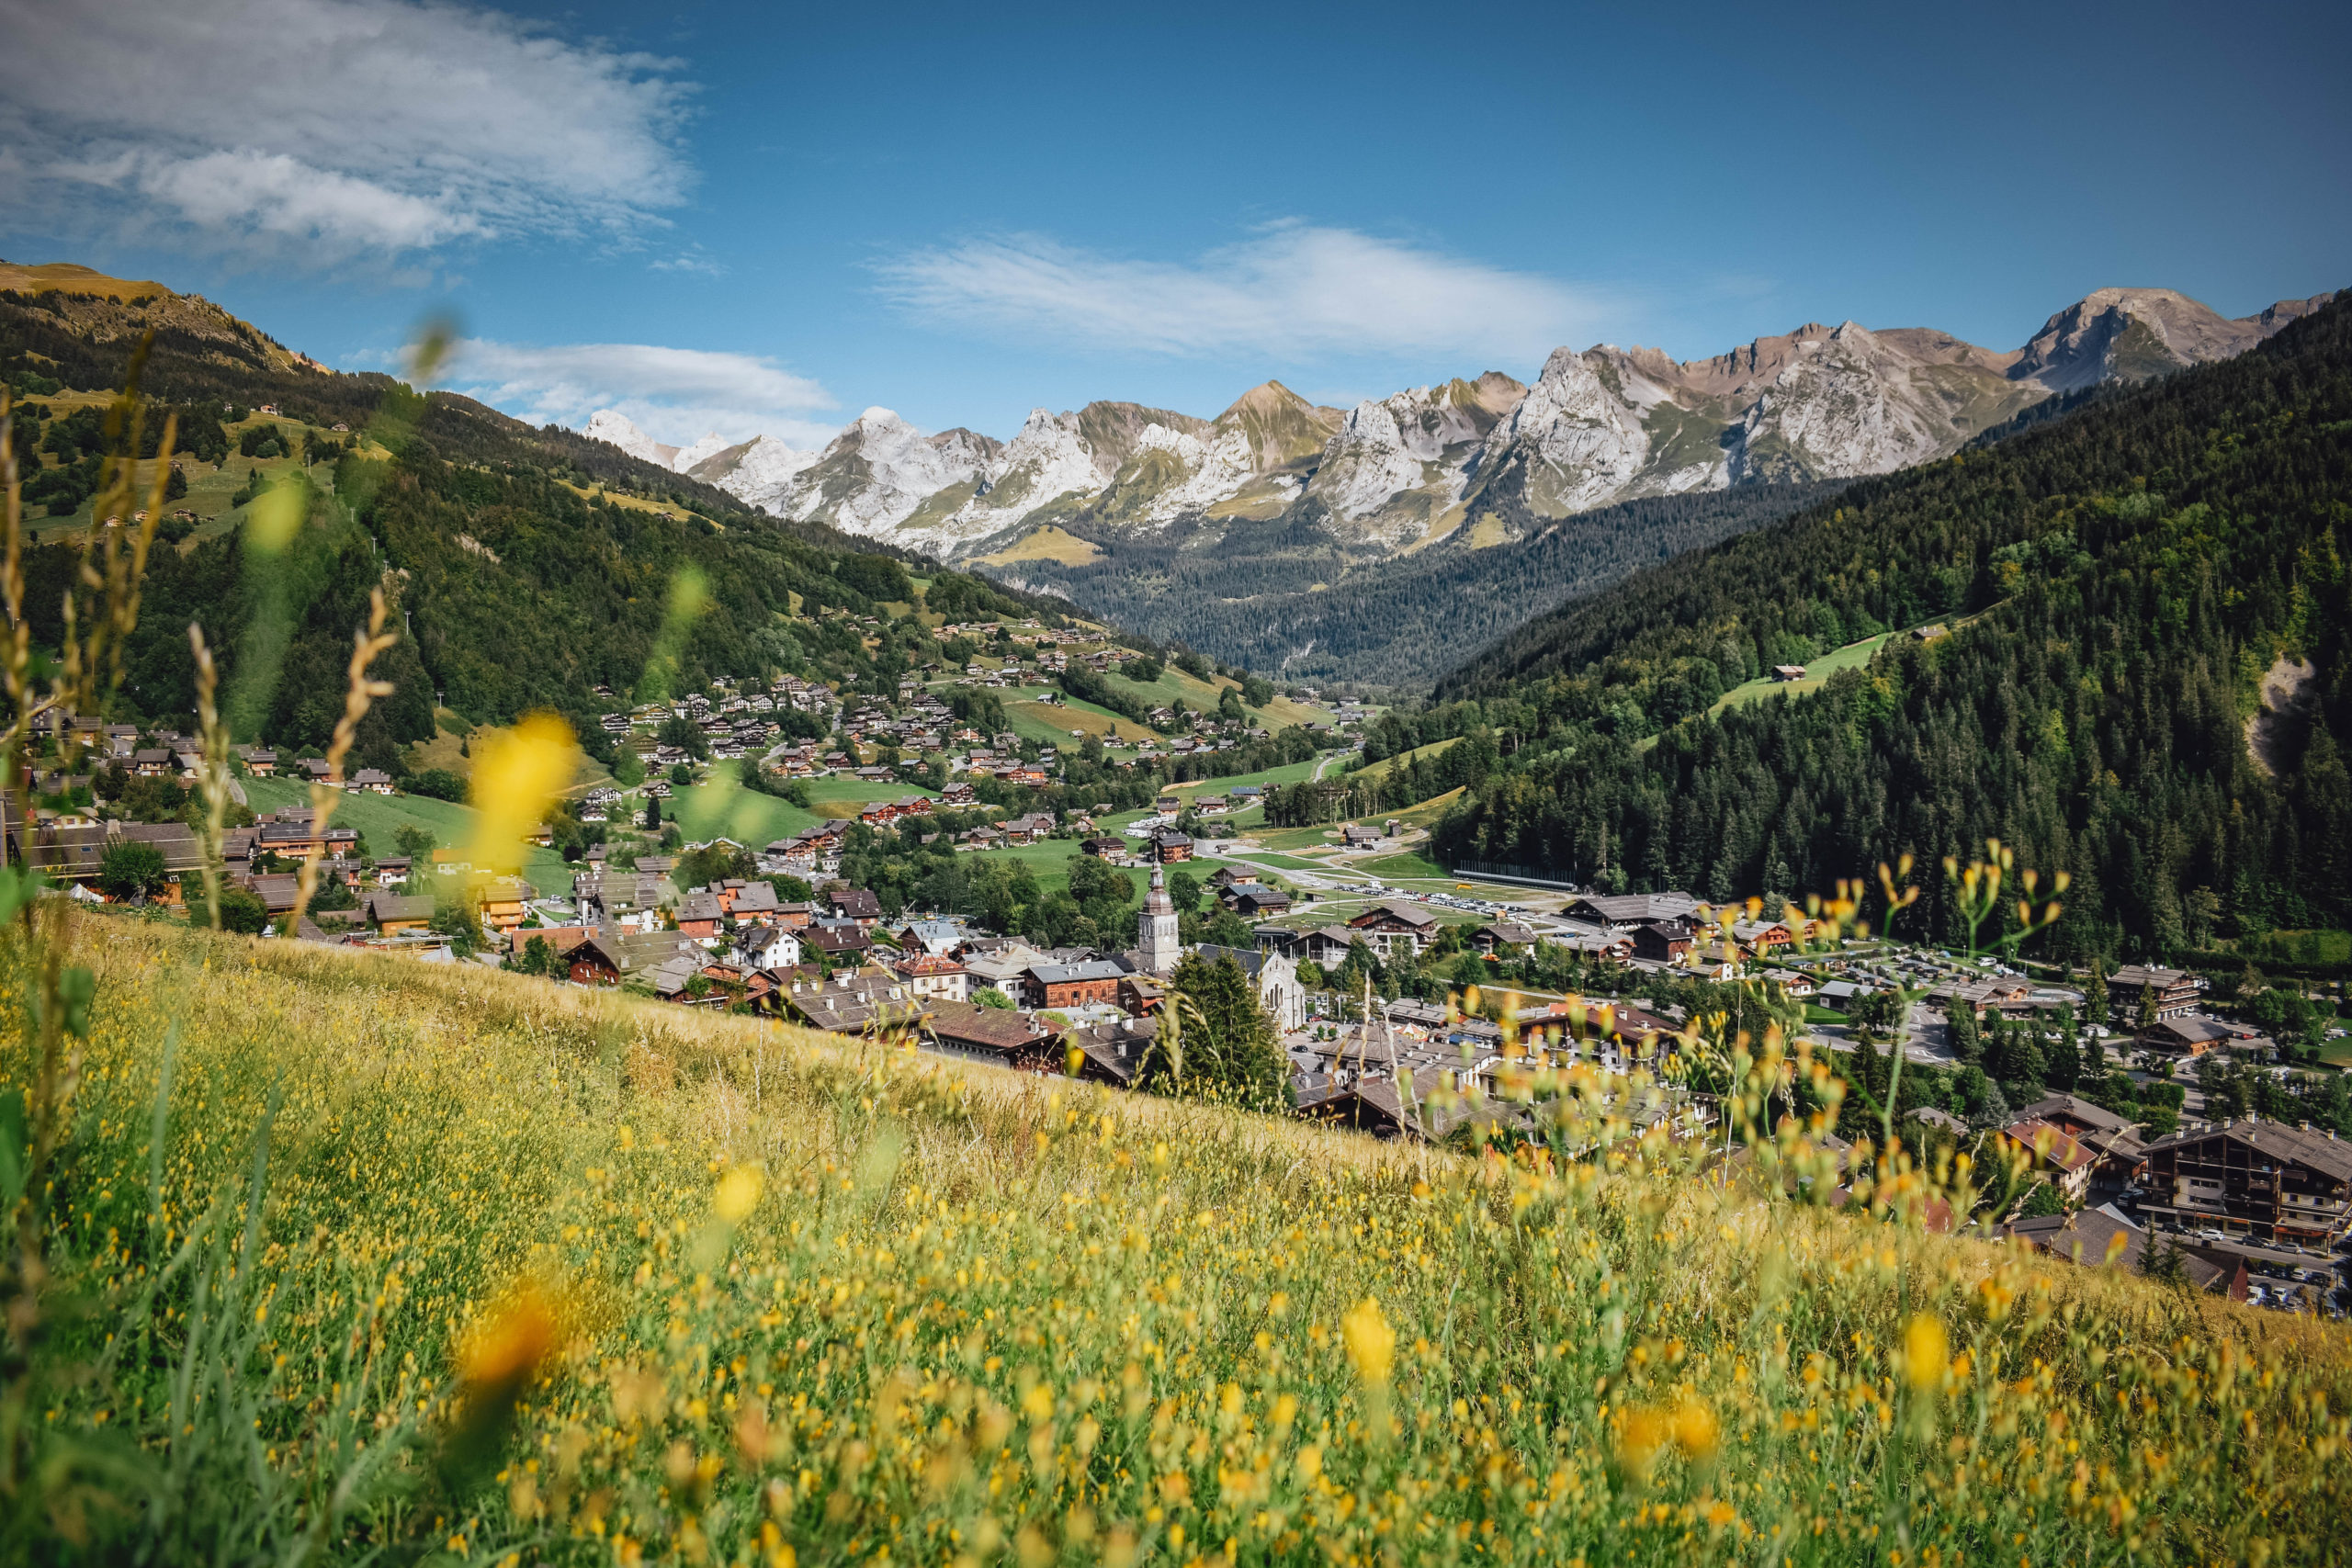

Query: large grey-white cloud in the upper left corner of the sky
[[0, 0, 692, 264]]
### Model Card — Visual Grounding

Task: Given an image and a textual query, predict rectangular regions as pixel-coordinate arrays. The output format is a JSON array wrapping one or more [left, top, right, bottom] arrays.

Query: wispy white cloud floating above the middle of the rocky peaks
[[879, 223, 1604, 360]]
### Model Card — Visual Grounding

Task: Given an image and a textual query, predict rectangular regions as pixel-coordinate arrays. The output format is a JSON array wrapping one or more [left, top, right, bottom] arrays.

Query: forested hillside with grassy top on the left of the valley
[[0, 280, 1056, 771]]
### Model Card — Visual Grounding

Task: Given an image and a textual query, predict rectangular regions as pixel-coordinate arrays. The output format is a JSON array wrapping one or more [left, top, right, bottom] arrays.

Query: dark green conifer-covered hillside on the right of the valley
[[1387, 292, 2352, 952]]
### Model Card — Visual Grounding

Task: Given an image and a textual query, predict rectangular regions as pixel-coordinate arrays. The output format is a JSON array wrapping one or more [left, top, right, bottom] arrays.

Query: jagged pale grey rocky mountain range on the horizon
[[588, 289, 2331, 559]]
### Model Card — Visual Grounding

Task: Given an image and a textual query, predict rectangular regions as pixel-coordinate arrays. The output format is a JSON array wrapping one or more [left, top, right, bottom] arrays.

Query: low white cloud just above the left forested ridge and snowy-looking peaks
[[437, 339, 835, 446]]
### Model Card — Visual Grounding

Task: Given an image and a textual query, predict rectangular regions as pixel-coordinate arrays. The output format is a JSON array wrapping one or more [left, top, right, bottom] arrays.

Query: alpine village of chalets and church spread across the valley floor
[[21, 594, 2352, 1312]]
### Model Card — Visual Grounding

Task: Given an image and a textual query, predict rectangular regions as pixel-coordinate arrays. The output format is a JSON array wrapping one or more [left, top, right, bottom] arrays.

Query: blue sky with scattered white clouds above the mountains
[[0, 0, 2352, 445]]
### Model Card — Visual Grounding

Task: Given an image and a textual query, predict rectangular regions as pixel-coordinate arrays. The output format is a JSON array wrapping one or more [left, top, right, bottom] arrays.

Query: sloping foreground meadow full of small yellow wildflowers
[[0, 919, 2352, 1565]]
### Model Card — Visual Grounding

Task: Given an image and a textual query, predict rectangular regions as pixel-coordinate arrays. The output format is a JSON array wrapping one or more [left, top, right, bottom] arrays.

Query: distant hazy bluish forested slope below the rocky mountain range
[[988, 482, 1844, 686]]
